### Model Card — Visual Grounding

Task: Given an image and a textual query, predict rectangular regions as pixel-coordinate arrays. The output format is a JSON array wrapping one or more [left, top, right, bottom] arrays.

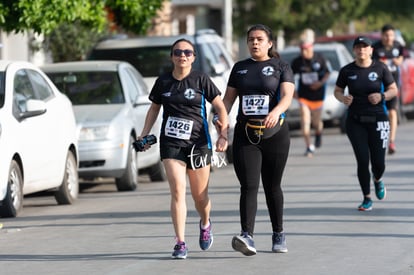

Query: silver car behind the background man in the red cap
[[279, 43, 353, 132]]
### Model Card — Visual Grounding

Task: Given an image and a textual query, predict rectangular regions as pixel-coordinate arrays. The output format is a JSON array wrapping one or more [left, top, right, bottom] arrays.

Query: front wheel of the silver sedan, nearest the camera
[[115, 137, 138, 191]]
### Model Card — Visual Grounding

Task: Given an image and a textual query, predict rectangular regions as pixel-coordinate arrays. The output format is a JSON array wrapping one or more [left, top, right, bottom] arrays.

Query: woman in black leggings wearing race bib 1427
[[218, 24, 294, 256]]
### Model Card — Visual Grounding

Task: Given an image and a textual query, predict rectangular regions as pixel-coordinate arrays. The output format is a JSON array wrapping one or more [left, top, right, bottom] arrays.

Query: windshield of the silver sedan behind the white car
[[47, 72, 125, 105]]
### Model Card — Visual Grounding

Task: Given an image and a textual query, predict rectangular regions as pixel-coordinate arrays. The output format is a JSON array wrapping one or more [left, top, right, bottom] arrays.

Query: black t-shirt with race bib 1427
[[228, 58, 295, 121]]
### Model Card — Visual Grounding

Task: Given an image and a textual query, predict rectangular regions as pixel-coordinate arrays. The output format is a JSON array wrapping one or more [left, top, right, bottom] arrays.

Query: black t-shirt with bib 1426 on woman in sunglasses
[[149, 71, 221, 148]]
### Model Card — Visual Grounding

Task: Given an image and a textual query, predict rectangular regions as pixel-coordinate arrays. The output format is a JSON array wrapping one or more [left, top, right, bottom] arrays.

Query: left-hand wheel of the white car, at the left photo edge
[[0, 160, 23, 218]]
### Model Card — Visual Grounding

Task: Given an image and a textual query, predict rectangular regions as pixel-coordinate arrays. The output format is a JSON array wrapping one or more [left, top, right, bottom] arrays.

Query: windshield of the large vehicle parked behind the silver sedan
[[88, 46, 201, 77]]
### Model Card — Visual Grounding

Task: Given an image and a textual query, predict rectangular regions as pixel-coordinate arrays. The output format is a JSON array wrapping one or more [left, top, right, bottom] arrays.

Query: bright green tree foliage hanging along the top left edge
[[0, 0, 163, 34]]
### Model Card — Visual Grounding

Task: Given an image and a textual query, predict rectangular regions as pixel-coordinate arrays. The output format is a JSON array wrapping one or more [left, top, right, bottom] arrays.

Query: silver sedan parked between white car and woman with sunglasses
[[41, 61, 166, 191]]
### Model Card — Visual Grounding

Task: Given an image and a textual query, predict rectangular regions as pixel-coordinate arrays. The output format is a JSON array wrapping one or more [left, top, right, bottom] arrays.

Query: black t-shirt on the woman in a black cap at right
[[336, 60, 394, 114]]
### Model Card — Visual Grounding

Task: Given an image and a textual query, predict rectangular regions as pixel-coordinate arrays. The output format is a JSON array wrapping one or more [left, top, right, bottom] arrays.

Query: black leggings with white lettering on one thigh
[[346, 115, 390, 196]]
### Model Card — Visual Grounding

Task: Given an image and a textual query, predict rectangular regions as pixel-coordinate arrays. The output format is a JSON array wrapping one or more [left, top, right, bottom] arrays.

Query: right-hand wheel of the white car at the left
[[55, 151, 79, 204]]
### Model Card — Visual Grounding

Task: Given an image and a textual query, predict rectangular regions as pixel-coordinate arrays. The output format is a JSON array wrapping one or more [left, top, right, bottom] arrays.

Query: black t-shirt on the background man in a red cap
[[292, 53, 329, 100]]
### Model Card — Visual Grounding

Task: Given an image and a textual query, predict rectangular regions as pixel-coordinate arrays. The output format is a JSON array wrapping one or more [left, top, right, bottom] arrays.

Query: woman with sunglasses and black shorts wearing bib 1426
[[138, 39, 228, 259]]
